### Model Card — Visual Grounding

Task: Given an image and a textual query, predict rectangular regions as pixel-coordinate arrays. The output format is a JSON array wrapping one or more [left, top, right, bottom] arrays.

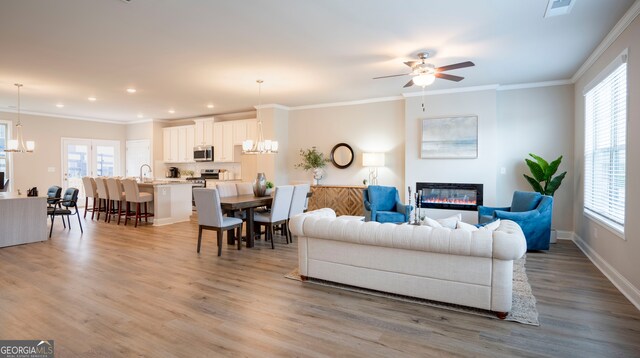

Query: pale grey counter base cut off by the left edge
[[0, 193, 48, 247]]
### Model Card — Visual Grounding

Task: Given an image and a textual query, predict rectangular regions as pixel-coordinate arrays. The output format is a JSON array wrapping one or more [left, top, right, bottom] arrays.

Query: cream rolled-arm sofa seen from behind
[[290, 208, 527, 318]]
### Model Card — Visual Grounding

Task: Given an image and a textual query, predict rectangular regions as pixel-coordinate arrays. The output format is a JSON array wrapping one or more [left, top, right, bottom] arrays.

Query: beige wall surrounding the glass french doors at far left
[[0, 113, 126, 193]]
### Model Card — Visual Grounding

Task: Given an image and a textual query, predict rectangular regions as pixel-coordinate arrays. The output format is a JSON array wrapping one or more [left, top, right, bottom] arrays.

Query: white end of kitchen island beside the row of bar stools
[[138, 180, 193, 226]]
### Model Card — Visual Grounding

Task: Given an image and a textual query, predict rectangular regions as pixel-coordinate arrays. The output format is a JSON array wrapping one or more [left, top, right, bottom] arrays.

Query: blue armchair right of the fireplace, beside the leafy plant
[[478, 191, 553, 250]]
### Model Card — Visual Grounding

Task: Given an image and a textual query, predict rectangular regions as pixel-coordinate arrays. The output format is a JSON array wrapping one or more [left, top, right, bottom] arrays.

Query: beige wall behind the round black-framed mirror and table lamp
[[288, 100, 405, 190]]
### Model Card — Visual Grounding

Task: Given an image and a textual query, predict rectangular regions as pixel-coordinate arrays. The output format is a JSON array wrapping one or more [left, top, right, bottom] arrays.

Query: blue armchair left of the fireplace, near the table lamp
[[362, 185, 413, 223]]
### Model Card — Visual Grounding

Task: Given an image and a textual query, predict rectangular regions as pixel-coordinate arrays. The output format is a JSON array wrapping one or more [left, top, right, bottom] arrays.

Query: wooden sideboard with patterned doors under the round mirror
[[308, 185, 366, 216]]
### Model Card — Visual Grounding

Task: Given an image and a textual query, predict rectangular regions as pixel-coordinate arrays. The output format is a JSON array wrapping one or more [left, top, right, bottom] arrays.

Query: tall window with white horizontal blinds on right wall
[[584, 50, 627, 234]]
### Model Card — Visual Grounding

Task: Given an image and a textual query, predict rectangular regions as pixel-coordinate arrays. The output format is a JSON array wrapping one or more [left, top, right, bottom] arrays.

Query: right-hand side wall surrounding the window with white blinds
[[573, 13, 640, 307]]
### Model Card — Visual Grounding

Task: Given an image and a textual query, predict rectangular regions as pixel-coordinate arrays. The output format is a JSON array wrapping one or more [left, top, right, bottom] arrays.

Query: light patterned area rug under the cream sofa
[[284, 256, 540, 326]]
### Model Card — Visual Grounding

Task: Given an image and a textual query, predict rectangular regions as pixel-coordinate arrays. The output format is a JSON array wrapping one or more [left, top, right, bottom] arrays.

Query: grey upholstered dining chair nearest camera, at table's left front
[[193, 188, 242, 256]]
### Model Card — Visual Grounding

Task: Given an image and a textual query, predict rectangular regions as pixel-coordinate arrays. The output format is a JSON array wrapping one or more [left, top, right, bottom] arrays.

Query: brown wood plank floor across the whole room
[[0, 220, 640, 357]]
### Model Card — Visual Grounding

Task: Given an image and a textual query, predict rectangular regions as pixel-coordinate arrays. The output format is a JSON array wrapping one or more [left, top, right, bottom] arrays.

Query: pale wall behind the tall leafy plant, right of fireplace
[[496, 85, 575, 231]]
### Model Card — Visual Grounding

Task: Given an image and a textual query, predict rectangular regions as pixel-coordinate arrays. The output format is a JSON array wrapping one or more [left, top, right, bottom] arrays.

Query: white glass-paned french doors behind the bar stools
[[62, 138, 121, 206]]
